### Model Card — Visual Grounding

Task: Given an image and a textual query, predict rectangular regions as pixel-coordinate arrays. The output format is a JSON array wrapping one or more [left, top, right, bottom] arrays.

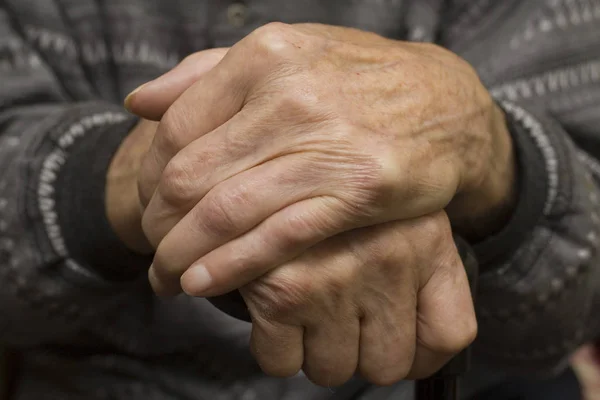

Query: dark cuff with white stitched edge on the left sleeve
[[38, 103, 151, 281]]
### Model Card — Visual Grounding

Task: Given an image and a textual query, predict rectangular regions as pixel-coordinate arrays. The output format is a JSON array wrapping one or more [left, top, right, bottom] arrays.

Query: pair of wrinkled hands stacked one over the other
[[116, 24, 514, 386]]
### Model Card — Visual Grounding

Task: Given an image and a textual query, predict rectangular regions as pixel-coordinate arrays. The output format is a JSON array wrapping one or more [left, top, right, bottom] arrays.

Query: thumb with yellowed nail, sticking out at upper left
[[125, 48, 229, 121]]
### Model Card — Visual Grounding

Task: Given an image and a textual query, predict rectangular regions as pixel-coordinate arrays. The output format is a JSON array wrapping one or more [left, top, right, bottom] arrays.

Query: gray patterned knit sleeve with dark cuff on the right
[[444, 0, 600, 373]]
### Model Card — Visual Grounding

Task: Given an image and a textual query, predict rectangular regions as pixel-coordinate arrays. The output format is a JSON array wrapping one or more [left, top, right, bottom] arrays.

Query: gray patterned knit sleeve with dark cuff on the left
[[0, 2, 149, 346]]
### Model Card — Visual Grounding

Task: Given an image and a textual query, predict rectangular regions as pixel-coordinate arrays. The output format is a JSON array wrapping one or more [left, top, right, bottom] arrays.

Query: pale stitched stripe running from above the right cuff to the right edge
[[490, 59, 600, 101]]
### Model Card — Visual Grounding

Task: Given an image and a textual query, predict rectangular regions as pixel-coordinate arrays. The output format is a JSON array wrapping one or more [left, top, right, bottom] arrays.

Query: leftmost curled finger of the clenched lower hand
[[242, 310, 304, 378]]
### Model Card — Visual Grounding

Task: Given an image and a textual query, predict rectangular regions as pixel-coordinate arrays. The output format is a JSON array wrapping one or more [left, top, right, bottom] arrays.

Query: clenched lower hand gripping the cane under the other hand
[[240, 212, 477, 386]]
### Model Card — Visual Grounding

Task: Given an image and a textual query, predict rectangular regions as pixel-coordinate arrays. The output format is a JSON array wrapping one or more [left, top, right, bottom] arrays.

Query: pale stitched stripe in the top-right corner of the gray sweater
[[510, 0, 600, 49]]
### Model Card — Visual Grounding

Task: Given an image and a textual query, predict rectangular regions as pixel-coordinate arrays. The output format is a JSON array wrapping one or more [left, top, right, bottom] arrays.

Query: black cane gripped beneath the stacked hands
[[209, 236, 479, 400]]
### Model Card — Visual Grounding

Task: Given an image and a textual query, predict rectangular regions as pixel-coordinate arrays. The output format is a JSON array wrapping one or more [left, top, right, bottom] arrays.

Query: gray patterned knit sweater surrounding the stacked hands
[[0, 0, 600, 400]]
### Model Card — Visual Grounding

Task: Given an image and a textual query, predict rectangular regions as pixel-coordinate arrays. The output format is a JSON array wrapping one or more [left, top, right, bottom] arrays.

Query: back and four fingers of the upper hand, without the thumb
[[130, 24, 507, 296]]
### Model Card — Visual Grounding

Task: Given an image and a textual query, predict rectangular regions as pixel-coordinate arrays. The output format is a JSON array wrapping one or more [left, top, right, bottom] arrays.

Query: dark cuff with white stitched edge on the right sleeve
[[473, 102, 556, 272]]
